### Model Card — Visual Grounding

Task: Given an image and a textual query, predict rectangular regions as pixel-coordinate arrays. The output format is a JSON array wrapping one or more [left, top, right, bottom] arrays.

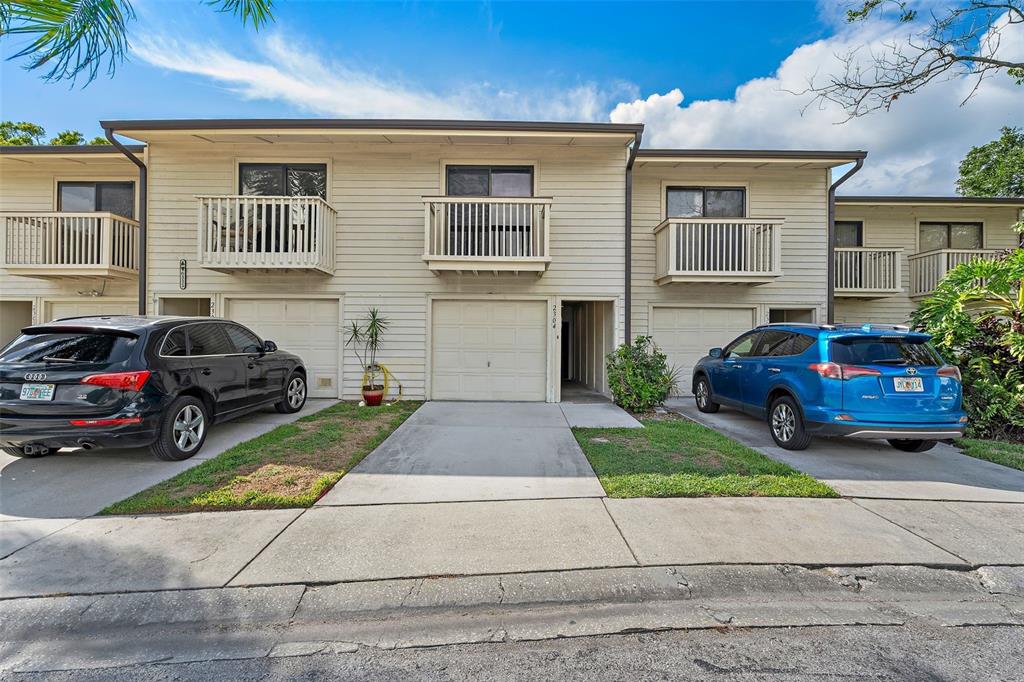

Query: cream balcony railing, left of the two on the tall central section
[[197, 196, 337, 274]]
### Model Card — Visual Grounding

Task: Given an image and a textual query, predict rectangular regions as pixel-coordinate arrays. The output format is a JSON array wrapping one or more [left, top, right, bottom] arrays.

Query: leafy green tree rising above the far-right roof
[[956, 127, 1024, 197]]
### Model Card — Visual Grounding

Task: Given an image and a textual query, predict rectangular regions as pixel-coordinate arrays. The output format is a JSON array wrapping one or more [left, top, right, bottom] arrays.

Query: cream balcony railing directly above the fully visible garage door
[[423, 197, 552, 273]]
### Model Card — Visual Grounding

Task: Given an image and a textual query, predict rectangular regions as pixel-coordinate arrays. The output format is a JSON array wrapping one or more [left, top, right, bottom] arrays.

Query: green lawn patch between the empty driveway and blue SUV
[[573, 411, 839, 498]]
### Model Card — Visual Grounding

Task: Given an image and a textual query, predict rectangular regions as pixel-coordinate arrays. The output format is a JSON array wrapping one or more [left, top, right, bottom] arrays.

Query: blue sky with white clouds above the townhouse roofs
[[0, 0, 1024, 194]]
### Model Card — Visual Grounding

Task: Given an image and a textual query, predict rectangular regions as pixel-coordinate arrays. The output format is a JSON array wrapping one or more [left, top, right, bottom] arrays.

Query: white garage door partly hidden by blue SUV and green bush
[[650, 306, 755, 382]]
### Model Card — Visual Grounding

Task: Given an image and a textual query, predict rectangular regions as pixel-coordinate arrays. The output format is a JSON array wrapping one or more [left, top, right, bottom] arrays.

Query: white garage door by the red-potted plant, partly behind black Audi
[[224, 298, 341, 397]]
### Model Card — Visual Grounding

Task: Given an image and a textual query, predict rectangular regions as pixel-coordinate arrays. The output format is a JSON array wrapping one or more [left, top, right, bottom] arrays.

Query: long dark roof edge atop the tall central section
[[99, 119, 643, 135]]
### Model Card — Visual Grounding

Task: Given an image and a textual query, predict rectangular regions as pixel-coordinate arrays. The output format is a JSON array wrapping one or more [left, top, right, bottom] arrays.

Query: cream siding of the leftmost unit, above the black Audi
[[0, 156, 138, 322]]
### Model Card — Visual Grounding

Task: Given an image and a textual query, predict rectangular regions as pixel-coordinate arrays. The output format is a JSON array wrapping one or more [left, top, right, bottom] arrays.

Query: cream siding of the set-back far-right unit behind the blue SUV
[[836, 203, 1018, 325]]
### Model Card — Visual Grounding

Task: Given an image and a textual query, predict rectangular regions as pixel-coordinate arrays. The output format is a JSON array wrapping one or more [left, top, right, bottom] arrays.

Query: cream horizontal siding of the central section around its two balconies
[[148, 138, 626, 399]]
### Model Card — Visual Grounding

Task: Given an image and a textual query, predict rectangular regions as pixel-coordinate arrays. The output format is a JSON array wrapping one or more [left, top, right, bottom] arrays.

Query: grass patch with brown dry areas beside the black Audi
[[100, 401, 420, 514]]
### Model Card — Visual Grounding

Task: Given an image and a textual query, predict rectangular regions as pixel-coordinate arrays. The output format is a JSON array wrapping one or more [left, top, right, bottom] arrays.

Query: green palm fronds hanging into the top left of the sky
[[0, 0, 273, 84]]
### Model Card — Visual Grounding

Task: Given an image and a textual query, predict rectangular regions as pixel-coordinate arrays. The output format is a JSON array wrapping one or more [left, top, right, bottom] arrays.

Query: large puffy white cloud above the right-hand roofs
[[610, 13, 1024, 194]]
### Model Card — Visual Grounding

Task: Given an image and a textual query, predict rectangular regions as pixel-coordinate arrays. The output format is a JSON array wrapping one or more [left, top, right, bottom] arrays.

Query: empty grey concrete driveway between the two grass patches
[[317, 402, 614, 506]]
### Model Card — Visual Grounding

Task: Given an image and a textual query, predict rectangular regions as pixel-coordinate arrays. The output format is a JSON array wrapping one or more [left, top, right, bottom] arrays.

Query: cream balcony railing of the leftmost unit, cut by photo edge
[[0, 211, 138, 278]]
